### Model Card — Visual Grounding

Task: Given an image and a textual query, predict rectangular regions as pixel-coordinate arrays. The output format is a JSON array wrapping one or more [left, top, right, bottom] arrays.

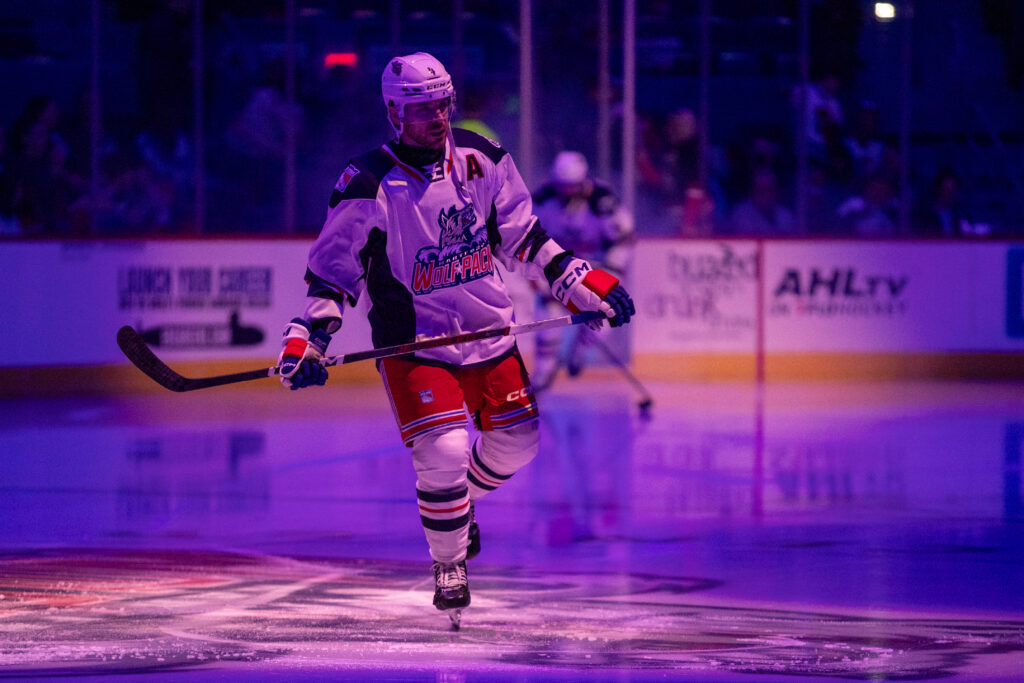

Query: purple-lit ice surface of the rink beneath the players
[[0, 380, 1024, 681]]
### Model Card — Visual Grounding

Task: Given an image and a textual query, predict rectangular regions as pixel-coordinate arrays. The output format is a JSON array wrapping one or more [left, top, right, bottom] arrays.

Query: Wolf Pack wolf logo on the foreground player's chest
[[413, 204, 494, 294]]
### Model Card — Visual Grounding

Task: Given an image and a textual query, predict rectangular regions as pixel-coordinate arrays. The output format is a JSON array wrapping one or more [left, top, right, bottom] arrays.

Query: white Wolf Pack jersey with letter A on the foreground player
[[306, 129, 562, 366]]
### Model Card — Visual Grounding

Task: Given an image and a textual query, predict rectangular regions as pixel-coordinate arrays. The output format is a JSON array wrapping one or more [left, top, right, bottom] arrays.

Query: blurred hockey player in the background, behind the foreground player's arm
[[532, 152, 634, 391]]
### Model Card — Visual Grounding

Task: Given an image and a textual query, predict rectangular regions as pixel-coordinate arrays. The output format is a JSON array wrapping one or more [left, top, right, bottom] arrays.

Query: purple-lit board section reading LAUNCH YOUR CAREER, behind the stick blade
[[0, 241, 370, 367]]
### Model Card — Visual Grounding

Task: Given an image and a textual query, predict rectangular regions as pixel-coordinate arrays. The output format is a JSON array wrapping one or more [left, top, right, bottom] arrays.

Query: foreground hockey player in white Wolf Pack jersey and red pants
[[279, 52, 634, 627]]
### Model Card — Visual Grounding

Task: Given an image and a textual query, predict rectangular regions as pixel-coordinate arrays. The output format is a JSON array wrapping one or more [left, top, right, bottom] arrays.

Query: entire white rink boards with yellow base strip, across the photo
[[0, 240, 1024, 388]]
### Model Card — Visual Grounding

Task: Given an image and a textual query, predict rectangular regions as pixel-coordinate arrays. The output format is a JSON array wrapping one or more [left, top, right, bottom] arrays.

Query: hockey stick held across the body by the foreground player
[[118, 312, 604, 391]]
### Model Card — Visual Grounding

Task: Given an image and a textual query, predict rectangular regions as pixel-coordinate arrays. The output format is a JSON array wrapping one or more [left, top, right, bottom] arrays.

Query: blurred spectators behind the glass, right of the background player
[[637, 90, 983, 238]]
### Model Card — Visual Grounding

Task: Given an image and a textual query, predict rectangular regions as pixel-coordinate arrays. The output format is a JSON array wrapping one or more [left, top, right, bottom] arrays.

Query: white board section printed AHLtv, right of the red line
[[763, 242, 1024, 353]]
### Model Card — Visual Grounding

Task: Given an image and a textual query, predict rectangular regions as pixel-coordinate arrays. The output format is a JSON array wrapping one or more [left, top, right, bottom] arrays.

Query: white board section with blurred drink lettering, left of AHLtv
[[629, 240, 757, 352]]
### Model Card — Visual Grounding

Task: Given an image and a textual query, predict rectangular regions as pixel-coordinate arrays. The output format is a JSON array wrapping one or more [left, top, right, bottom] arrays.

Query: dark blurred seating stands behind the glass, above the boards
[[0, 0, 1024, 239]]
